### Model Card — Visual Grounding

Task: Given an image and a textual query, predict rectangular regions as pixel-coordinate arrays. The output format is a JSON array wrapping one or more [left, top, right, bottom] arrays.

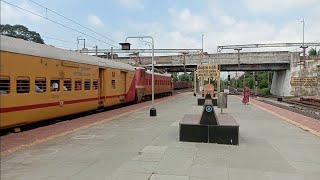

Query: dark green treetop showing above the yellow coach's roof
[[0, 24, 44, 44]]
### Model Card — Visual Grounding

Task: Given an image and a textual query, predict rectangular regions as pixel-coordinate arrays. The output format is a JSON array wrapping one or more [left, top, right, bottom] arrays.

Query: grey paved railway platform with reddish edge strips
[[1, 93, 320, 180]]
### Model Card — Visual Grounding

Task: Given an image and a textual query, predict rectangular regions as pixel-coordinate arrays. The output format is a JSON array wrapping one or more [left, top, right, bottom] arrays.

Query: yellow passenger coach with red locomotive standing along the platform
[[0, 35, 173, 129]]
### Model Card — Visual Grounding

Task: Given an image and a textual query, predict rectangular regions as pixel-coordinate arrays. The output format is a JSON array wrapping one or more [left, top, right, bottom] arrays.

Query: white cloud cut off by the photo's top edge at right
[[244, 0, 320, 13]]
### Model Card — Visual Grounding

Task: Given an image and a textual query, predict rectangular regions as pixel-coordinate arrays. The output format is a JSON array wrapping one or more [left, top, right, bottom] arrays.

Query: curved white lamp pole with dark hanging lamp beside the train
[[120, 36, 157, 116]]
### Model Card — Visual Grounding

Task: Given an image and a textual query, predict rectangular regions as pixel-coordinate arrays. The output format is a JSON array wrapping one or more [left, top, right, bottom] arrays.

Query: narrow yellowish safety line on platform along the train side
[[0, 93, 188, 156]]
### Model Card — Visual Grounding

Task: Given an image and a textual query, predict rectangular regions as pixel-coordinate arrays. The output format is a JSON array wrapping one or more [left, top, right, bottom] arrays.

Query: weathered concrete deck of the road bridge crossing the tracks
[[120, 51, 300, 72]]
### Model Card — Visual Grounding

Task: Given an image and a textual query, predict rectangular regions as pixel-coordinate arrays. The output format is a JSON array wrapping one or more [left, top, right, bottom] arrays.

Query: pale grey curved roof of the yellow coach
[[0, 35, 134, 71]]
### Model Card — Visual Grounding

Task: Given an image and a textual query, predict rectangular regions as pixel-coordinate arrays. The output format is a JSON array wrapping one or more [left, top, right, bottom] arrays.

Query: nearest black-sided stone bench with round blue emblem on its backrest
[[179, 100, 239, 145]]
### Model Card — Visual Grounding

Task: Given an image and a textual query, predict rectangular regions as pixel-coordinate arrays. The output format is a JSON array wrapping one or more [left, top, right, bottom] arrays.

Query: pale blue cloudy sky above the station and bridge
[[1, 0, 320, 53]]
